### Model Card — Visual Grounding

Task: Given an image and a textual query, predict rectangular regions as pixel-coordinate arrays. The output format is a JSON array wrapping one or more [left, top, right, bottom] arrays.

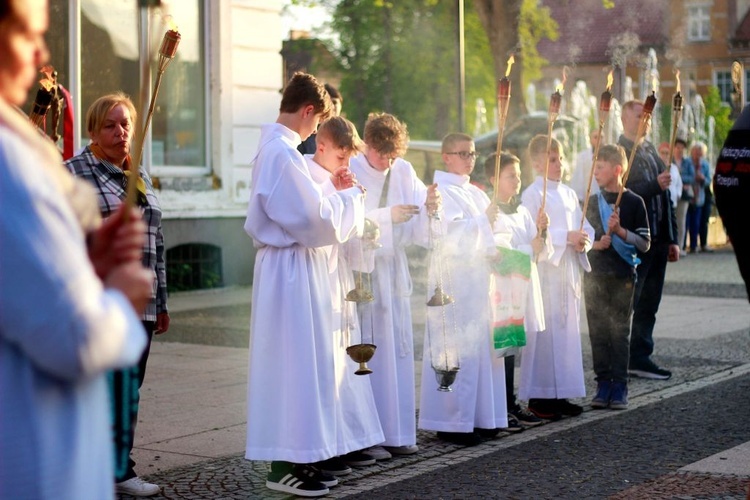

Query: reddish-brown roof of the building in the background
[[538, 0, 669, 65]]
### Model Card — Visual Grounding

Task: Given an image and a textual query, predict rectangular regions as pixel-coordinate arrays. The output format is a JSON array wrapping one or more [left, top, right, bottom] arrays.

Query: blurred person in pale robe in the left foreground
[[0, 0, 153, 500]]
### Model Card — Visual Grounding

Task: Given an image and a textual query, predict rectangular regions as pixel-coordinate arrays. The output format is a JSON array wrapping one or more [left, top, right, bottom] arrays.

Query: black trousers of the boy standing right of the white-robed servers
[[583, 273, 636, 383]]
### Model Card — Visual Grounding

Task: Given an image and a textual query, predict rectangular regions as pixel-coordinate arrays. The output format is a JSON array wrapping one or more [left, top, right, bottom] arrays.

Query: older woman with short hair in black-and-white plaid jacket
[[65, 92, 169, 496]]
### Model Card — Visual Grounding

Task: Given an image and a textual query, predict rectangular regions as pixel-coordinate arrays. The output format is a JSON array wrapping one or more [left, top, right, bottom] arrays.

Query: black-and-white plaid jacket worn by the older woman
[[65, 146, 167, 321]]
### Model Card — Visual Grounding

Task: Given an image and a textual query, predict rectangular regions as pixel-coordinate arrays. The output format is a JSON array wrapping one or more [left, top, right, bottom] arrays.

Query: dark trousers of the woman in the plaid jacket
[[109, 321, 156, 483]]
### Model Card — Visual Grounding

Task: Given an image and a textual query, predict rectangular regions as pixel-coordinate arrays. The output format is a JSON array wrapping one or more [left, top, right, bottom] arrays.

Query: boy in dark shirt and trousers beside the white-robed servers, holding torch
[[584, 145, 651, 410]]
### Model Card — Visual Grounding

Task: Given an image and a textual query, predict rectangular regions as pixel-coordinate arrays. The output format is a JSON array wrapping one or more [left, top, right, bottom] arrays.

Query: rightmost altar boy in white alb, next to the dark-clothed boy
[[518, 135, 594, 420]]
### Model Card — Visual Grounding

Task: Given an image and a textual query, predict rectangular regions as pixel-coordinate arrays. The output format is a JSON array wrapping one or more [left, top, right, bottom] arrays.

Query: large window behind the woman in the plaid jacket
[[47, 0, 210, 175]]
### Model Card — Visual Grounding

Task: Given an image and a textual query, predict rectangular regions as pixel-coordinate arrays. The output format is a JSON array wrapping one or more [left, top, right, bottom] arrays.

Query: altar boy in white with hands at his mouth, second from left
[[305, 116, 384, 475]]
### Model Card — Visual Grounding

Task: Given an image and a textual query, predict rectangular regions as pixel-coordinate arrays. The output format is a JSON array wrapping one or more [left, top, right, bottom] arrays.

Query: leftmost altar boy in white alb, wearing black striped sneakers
[[245, 73, 364, 496]]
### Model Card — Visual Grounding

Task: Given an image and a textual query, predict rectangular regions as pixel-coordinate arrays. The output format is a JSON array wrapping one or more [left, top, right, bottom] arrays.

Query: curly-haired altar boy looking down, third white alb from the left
[[351, 113, 439, 460]]
